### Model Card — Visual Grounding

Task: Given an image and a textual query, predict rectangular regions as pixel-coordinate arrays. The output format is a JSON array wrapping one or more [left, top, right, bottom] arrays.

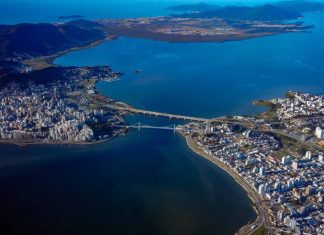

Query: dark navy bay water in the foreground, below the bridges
[[0, 118, 255, 234]]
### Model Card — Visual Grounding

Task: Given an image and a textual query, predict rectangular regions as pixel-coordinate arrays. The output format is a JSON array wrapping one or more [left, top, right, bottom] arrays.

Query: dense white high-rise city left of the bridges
[[0, 67, 124, 144]]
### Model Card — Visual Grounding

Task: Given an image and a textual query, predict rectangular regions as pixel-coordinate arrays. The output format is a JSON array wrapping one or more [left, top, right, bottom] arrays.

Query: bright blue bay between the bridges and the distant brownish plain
[[55, 13, 324, 117]]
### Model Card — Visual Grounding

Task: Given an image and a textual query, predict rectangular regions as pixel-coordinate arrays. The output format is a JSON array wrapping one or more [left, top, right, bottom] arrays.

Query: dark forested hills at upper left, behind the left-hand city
[[0, 20, 105, 58]]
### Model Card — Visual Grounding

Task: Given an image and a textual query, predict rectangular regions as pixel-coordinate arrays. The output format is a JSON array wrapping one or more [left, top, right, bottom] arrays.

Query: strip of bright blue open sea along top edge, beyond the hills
[[0, 0, 324, 24]]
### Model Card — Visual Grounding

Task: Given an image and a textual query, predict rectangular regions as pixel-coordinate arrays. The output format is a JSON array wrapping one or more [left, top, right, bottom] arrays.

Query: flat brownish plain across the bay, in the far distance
[[96, 16, 311, 42]]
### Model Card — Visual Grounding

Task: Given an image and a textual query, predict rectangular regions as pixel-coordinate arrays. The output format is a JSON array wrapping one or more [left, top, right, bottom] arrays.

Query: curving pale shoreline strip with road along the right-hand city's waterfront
[[180, 133, 269, 235]]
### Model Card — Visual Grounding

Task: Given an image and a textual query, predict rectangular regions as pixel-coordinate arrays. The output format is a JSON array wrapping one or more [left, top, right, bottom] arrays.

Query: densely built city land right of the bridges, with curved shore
[[181, 92, 324, 234]]
